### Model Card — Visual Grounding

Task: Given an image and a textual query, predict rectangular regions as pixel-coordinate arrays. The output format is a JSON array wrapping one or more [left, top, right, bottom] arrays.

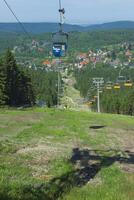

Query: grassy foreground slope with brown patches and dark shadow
[[0, 110, 134, 200]]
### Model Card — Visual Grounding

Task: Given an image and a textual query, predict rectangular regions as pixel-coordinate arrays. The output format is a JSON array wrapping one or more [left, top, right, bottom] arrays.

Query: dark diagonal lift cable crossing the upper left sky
[[3, 0, 33, 40]]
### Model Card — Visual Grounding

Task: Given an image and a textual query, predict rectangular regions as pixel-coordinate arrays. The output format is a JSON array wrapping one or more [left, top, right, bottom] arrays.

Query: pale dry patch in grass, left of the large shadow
[[16, 142, 72, 177]]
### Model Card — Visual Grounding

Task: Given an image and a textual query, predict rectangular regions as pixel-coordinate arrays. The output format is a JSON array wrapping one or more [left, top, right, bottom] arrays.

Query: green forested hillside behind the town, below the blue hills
[[0, 29, 134, 54]]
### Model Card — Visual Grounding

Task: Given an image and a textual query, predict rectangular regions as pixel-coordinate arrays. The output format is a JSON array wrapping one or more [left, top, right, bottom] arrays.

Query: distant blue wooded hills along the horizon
[[0, 21, 134, 34]]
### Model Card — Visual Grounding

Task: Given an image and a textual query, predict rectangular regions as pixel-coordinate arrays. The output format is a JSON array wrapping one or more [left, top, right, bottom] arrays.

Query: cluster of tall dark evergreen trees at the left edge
[[0, 50, 35, 106]]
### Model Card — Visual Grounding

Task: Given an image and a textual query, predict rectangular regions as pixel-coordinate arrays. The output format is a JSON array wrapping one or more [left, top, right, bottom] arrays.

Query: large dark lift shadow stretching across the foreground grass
[[0, 148, 134, 200]]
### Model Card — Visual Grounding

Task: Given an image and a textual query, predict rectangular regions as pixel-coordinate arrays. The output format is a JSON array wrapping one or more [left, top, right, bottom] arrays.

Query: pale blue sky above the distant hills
[[0, 0, 134, 24]]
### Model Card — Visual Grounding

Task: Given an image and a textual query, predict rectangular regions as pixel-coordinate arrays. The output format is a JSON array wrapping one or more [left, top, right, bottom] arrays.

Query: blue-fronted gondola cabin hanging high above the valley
[[52, 31, 68, 58]]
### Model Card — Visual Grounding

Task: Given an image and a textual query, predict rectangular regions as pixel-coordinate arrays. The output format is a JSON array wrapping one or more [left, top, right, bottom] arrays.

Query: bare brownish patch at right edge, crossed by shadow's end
[[101, 128, 134, 173]]
